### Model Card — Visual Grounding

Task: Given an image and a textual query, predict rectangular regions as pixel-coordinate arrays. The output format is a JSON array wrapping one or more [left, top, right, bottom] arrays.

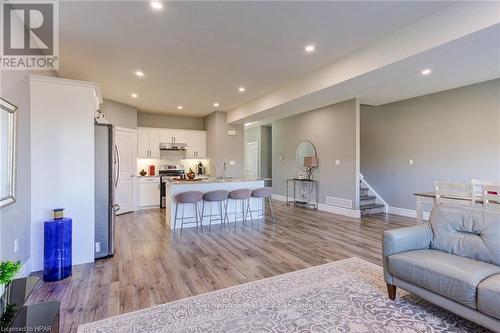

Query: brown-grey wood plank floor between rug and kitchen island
[[29, 202, 415, 333]]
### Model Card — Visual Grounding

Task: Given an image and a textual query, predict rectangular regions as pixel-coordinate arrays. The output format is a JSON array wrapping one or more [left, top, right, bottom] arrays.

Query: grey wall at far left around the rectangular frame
[[0, 71, 55, 263]]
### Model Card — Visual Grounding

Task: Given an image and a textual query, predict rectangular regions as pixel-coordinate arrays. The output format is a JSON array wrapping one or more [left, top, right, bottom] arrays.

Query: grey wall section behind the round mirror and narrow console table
[[272, 99, 359, 208]]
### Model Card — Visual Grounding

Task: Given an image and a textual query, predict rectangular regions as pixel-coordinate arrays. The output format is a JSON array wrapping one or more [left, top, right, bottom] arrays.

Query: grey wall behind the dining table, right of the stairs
[[361, 80, 500, 209]]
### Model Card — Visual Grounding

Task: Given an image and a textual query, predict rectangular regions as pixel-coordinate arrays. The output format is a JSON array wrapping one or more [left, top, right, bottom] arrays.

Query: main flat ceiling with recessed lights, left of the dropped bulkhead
[[55, 1, 451, 116]]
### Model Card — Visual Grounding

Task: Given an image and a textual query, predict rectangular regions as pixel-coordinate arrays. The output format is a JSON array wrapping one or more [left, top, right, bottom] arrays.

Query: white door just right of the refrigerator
[[115, 127, 137, 214]]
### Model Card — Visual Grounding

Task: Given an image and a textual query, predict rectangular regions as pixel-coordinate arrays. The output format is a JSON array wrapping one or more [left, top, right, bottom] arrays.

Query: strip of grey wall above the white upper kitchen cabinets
[[137, 112, 203, 130]]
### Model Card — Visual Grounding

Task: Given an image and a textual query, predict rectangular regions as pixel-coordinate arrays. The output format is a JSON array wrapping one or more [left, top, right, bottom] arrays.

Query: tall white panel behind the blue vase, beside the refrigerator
[[30, 77, 96, 271]]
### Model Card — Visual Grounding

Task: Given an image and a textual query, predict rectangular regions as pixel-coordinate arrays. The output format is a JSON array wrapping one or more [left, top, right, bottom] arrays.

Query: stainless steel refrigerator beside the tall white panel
[[94, 124, 120, 259]]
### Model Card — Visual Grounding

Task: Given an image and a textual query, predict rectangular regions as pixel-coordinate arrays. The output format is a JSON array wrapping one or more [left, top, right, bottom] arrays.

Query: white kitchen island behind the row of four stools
[[165, 178, 264, 229]]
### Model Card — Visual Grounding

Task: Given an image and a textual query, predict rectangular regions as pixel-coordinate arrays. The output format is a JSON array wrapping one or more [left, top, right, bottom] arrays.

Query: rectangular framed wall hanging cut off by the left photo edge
[[0, 98, 17, 207]]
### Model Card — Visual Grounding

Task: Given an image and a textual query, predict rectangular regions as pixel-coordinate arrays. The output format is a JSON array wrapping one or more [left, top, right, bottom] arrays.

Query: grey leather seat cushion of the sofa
[[388, 250, 500, 309]]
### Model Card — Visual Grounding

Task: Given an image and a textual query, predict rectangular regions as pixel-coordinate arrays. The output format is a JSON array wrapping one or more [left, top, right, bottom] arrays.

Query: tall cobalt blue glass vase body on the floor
[[43, 217, 72, 281]]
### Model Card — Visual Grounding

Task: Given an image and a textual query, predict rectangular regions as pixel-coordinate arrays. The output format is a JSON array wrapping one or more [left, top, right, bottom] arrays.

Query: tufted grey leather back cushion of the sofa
[[429, 205, 500, 265]]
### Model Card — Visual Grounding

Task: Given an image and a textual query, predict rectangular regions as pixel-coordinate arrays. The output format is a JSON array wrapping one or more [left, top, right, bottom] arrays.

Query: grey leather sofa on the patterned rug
[[383, 205, 500, 332]]
